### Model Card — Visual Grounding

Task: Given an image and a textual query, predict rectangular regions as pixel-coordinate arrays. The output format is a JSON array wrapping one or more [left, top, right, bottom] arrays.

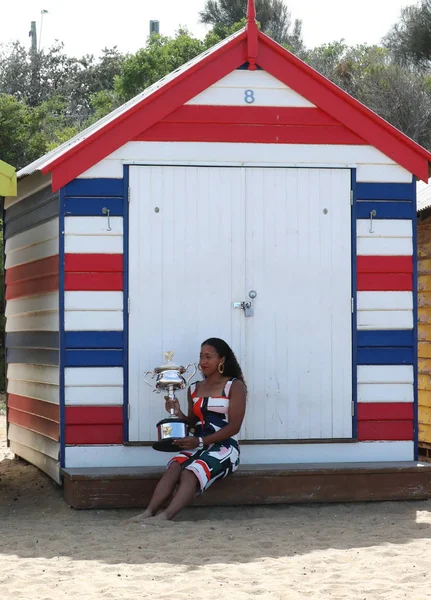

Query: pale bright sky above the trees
[[0, 0, 416, 56]]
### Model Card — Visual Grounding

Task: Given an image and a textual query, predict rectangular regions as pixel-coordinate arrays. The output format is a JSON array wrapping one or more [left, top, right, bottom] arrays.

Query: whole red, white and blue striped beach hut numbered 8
[[5, 0, 431, 508]]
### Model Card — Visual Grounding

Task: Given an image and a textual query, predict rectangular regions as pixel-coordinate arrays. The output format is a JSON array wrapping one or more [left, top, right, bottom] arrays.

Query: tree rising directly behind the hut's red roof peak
[[199, 0, 304, 53]]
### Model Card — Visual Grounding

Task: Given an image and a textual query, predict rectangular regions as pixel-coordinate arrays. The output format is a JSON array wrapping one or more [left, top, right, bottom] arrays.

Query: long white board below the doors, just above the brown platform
[[66, 442, 414, 469]]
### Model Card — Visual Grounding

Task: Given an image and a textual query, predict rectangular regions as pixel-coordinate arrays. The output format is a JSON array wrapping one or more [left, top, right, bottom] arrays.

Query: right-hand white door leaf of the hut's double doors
[[242, 169, 352, 440]]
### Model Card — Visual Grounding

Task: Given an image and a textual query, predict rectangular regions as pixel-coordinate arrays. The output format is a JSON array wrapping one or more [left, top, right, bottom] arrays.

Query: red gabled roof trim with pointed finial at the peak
[[35, 0, 431, 190]]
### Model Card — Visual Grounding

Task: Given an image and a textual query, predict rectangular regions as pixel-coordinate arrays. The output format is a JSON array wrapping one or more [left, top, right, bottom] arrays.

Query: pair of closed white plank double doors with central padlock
[[129, 167, 352, 441]]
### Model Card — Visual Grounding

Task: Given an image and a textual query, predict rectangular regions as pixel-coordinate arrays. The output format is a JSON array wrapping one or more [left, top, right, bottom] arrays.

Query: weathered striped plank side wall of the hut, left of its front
[[4, 178, 60, 482]]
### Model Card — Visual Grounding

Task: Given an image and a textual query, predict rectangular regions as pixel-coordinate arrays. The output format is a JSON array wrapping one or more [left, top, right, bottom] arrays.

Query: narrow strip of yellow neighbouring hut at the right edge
[[417, 181, 431, 460]]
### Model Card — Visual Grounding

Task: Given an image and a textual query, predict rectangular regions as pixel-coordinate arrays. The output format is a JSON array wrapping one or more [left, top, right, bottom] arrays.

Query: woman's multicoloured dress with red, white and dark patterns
[[168, 379, 240, 493]]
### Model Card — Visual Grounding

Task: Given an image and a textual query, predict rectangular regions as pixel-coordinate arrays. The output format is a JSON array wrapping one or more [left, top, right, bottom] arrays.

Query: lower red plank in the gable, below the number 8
[[133, 122, 365, 145]]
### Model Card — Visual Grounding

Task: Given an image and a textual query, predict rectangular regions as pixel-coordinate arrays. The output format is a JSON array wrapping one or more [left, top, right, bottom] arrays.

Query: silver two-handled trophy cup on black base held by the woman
[[144, 352, 197, 452]]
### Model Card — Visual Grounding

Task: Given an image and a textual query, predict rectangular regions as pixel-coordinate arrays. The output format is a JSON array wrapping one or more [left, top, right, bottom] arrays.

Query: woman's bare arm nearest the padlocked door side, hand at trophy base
[[175, 380, 246, 450]]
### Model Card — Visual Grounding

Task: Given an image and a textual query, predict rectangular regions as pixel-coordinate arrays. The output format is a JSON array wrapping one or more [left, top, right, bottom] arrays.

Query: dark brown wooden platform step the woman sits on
[[63, 462, 431, 509]]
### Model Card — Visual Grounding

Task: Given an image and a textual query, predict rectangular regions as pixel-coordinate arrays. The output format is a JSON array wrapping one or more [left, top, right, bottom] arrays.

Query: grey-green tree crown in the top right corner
[[384, 0, 431, 66]]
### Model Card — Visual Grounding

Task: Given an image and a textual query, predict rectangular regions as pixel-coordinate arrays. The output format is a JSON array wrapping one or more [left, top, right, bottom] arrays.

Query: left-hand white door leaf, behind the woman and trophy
[[129, 167, 245, 441]]
